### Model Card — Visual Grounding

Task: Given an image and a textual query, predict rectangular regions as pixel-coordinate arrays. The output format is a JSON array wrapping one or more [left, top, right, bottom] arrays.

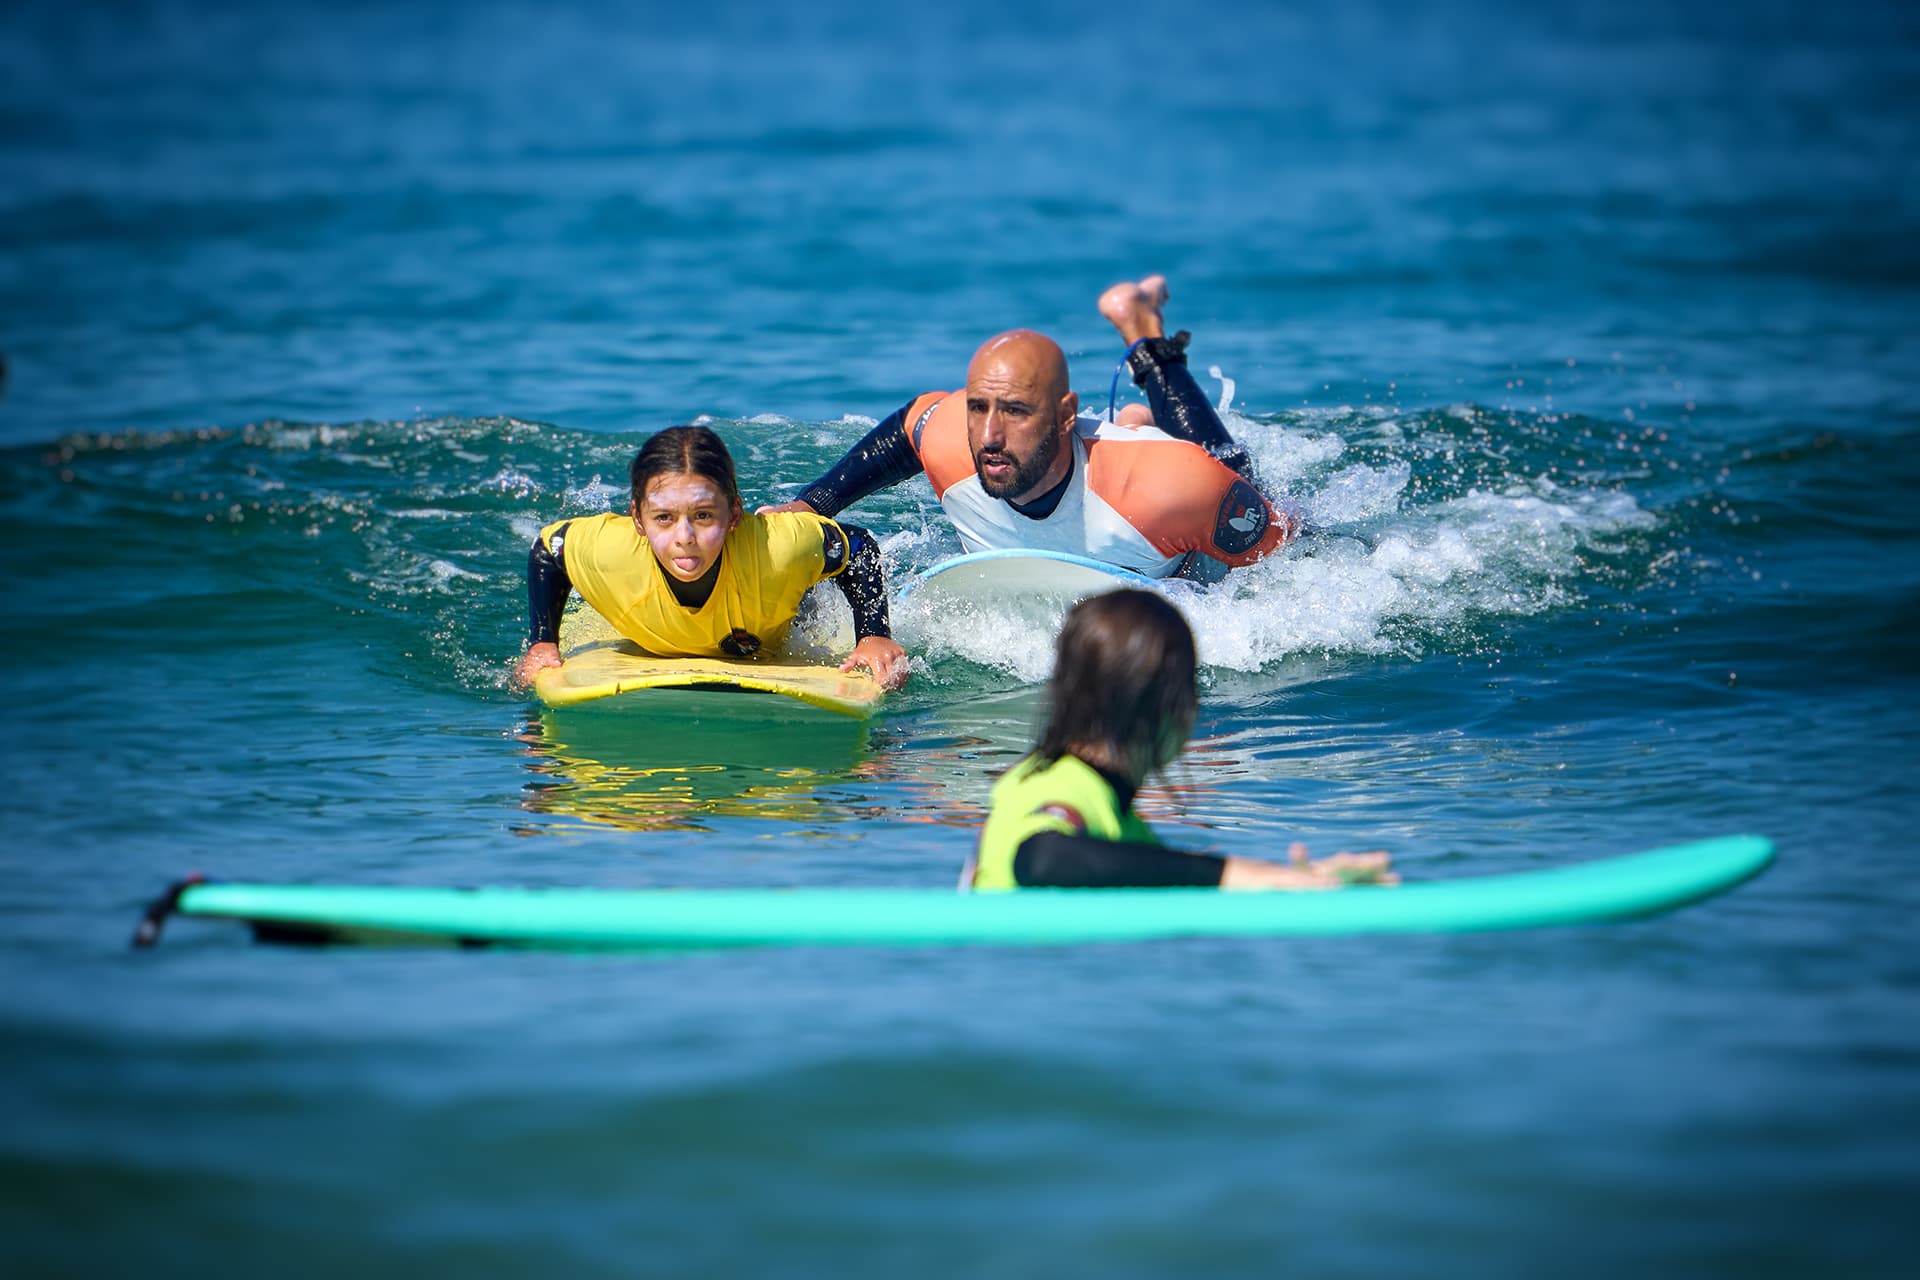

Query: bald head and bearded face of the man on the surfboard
[[966, 347, 1075, 503]]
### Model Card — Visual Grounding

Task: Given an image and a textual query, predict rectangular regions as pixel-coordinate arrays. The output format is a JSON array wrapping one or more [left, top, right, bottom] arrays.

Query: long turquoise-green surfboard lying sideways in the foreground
[[134, 835, 1774, 950]]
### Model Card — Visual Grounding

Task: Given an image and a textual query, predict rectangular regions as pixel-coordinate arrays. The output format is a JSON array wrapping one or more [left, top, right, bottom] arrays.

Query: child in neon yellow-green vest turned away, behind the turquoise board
[[962, 591, 1400, 889]]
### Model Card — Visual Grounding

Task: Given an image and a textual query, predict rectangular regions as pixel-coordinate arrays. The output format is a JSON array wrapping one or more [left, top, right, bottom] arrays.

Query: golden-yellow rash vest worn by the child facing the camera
[[540, 510, 839, 658]]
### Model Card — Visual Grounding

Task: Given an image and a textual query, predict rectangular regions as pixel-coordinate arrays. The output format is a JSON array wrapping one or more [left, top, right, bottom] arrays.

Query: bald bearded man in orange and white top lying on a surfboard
[[762, 276, 1298, 581]]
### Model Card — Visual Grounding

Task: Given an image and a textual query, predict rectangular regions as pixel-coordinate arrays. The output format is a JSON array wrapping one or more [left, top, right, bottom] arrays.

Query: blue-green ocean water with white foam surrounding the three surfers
[[0, 0, 1920, 1276]]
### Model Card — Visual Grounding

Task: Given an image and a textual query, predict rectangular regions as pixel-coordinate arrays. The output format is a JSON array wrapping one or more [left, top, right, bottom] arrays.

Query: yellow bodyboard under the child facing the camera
[[534, 608, 883, 716]]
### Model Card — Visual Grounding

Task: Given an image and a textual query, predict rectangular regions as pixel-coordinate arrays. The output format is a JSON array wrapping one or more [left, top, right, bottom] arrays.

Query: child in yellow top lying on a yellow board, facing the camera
[[515, 426, 908, 689]]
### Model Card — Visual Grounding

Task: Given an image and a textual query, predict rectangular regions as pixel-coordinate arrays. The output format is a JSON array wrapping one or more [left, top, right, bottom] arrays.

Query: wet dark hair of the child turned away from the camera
[[1037, 591, 1200, 777]]
